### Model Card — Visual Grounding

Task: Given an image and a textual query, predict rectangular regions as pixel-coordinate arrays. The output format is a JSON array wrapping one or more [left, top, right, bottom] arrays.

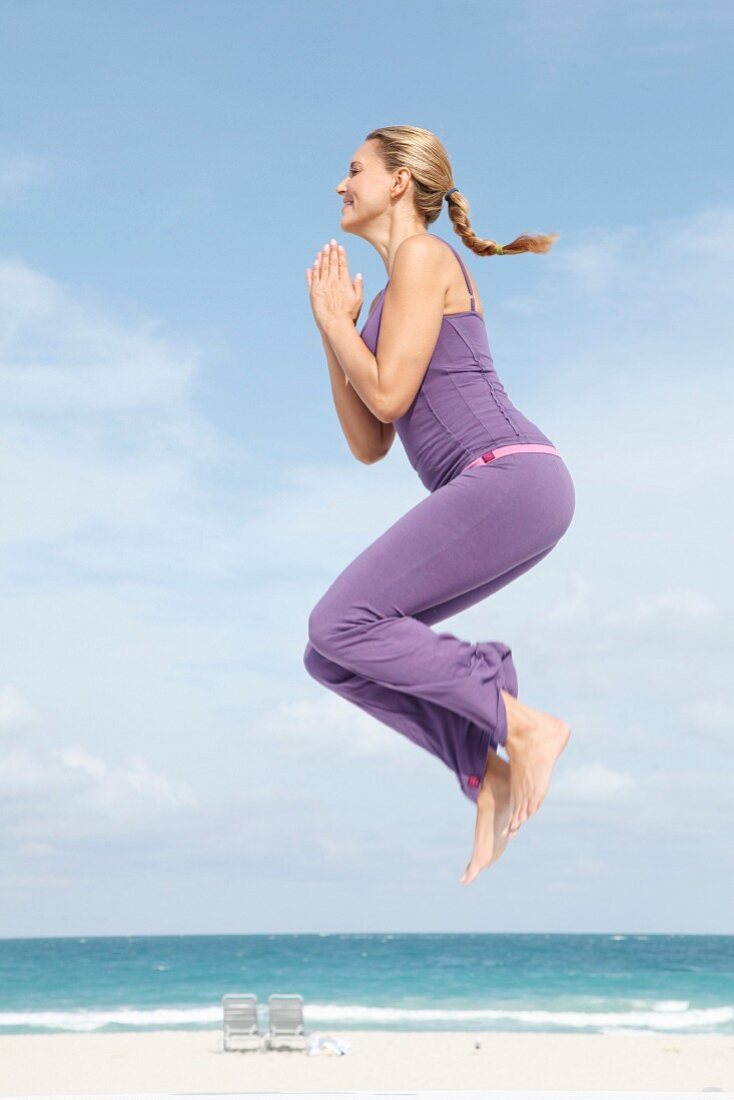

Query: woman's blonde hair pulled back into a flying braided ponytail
[[364, 127, 558, 256]]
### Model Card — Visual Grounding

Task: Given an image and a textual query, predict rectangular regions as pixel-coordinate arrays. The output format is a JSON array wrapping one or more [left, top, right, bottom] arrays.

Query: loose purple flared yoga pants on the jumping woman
[[304, 452, 576, 802]]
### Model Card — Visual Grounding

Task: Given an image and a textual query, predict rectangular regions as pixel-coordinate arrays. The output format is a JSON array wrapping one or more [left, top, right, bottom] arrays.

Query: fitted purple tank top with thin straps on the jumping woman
[[360, 233, 551, 493]]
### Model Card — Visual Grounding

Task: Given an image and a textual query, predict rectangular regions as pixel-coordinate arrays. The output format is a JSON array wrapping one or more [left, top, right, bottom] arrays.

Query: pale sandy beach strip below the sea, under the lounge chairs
[[0, 1030, 734, 1096]]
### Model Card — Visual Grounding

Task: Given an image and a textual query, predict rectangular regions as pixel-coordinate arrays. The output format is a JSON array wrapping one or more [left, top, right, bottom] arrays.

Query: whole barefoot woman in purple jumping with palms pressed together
[[304, 127, 576, 884]]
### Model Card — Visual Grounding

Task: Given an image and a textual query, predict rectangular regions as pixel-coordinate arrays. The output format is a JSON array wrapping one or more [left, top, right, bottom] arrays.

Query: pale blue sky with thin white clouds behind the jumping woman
[[0, 0, 734, 937]]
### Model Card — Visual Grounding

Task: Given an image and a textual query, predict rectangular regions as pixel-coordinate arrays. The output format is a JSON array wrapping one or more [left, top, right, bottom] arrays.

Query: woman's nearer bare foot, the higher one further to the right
[[502, 691, 571, 835]]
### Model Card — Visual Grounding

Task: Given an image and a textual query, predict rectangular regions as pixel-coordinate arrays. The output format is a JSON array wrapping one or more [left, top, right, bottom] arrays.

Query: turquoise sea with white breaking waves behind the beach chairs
[[0, 933, 734, 1035]]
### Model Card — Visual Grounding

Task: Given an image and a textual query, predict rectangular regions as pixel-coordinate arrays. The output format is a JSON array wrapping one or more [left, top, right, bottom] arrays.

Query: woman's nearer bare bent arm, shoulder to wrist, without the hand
[[325, 234, 446, 425]]
